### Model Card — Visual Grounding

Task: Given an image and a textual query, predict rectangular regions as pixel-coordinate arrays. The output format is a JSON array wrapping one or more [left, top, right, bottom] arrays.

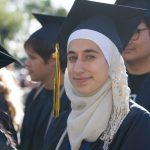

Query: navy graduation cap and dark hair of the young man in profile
[[24, 13, 64, 62]]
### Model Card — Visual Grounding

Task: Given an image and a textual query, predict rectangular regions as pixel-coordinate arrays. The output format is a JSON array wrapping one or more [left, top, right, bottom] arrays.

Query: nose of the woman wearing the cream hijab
[[74, 59, 84, 73]]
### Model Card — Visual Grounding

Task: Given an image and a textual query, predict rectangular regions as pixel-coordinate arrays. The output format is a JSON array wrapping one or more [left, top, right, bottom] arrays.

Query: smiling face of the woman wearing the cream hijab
[[67, 39, 109, 95]]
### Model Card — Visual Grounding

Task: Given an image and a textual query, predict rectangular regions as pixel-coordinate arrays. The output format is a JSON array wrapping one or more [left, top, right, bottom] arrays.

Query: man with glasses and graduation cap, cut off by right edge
[[115, 0, 150, 111]]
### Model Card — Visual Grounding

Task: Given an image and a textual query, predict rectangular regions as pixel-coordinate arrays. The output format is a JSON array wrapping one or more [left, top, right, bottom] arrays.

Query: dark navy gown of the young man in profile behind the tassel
[[19, 88, 70, 150]]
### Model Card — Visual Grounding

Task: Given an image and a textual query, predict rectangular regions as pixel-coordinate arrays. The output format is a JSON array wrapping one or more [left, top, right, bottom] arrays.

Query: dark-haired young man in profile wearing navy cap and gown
[[19, 14, 69, 150]]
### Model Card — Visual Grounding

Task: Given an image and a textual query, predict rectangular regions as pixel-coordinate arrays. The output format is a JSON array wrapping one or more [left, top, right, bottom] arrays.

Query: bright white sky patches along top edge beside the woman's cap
[[51, 0, 116, 11]]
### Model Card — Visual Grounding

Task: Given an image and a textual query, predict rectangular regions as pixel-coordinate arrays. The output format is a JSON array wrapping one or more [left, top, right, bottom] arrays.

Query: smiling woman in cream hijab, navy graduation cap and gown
[[43, 0, 150, 150]]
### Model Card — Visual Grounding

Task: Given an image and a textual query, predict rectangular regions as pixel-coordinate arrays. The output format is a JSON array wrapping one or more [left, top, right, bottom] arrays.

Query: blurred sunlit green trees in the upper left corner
[[0, 0, 67, 58]]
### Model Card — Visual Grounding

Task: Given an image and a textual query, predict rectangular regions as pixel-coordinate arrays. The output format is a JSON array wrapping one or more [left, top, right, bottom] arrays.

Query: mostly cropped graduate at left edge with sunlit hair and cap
[[0, 42, 22, 150]]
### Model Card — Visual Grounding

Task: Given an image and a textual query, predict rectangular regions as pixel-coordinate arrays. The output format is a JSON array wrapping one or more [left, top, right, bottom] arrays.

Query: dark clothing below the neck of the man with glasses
[[128, 73, 150, 111]]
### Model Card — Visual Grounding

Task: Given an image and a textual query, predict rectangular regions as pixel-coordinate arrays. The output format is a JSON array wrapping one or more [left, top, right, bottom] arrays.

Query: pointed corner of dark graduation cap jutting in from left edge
[[0, 45, 23, 68]]
